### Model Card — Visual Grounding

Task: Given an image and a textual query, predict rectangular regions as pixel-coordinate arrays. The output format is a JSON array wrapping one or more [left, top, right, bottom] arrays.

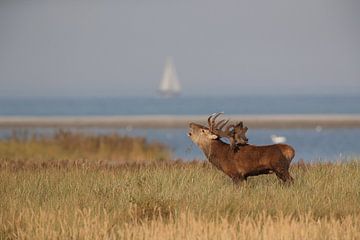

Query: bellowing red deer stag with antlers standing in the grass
[[188, 113, 295, 184]]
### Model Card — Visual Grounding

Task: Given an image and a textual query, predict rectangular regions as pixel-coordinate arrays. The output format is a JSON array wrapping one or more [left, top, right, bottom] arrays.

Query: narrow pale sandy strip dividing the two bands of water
[[0, 115, 360, 128]]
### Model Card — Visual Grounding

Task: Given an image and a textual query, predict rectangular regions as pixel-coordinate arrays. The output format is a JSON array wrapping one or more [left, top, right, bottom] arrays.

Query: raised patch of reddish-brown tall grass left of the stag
[[0, 130, 171, 167]]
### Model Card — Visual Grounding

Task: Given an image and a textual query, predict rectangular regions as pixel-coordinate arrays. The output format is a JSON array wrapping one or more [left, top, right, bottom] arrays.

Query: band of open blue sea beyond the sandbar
[[0, 96, 360, 116]]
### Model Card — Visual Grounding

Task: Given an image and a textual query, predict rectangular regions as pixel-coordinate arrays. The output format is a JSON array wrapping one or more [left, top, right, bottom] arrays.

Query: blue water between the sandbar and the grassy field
[[0, 128, 360, 162]]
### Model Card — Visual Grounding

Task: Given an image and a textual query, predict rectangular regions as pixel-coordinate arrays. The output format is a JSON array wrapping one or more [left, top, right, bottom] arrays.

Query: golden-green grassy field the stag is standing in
[[0, 133, 360, 239]]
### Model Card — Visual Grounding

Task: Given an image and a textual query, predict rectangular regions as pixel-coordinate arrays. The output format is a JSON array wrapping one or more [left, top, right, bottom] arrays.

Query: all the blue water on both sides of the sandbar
[[0, 96, 360, 161]]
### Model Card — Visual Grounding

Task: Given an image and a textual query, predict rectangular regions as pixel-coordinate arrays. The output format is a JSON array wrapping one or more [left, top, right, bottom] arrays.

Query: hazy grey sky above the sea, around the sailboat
[[0, 0, 360, 97]]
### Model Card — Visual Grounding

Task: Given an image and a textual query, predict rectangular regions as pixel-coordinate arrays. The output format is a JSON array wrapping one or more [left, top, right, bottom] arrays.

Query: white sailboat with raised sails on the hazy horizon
[[159, 57, 181, 97]]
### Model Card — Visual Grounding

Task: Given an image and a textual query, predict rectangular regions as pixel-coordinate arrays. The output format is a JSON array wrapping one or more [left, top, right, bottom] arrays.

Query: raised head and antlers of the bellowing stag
[[188, 113, 248, 149]]
